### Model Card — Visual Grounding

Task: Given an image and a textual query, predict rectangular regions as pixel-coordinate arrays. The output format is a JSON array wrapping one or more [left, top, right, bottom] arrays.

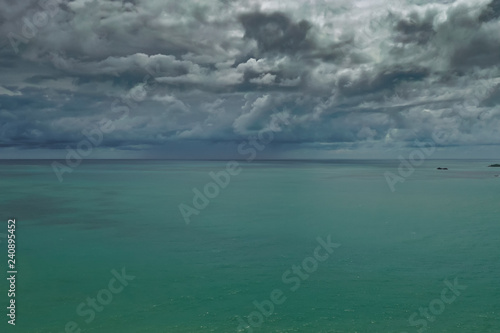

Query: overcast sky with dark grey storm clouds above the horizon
[[0, 0, 500, 159]]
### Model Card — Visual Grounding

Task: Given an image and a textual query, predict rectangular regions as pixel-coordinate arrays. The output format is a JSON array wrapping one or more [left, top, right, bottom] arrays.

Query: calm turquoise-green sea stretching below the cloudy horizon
[[0, 160, 500, 333]]
